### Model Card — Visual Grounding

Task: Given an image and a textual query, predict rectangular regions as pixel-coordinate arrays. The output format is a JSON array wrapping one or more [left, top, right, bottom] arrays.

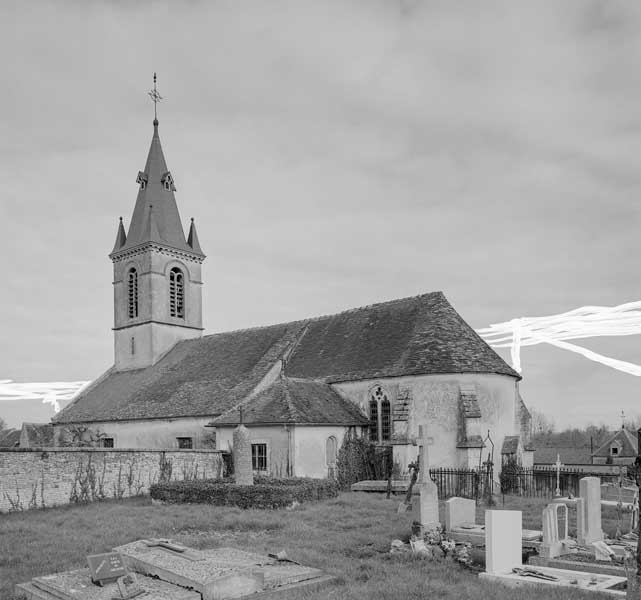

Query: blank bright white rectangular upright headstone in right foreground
[[485, 510, 523, 575]]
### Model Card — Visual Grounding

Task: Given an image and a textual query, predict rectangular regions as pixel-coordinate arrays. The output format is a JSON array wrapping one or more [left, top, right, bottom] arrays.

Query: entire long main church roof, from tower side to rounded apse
[[53, 292, 520, 423]]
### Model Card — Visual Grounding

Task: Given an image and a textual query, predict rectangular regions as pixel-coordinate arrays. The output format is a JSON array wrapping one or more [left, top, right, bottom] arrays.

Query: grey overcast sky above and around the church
[[0, 0, 641, 426]]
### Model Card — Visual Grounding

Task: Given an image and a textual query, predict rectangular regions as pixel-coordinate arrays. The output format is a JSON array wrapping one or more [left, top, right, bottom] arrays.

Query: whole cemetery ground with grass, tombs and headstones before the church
[[0, 426, 639, 600]]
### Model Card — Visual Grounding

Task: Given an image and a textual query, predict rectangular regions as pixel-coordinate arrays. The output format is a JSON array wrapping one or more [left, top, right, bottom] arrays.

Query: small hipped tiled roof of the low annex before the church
[[212, 377, 369, 425]]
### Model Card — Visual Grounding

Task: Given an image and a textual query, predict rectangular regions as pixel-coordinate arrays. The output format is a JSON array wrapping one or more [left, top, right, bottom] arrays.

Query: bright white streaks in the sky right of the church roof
[[476, 301, 641, 377]]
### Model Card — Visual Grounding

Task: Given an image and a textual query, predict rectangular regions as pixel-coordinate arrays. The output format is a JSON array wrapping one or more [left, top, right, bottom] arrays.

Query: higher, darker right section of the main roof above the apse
[[287, 292, 521, 382]]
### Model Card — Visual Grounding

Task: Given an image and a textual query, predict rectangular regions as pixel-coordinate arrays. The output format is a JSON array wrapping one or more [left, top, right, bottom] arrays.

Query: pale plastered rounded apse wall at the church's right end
[[332, 373, 520, 472]]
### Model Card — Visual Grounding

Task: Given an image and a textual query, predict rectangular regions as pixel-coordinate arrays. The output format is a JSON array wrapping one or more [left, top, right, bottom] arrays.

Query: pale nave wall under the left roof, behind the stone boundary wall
[[54, 417, 213, 450]]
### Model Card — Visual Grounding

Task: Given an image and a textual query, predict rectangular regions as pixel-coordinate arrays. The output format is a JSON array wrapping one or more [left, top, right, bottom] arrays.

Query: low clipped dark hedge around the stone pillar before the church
[[149, 477, 338, 508]]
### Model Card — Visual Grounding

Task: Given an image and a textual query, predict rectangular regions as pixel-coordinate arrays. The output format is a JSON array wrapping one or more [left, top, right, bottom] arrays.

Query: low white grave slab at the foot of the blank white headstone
[[479, 567, 627, 598]]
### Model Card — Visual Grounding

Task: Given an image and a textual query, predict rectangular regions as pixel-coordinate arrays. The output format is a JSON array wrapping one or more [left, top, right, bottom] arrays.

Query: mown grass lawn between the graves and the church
[[0, 493, 628, 600]]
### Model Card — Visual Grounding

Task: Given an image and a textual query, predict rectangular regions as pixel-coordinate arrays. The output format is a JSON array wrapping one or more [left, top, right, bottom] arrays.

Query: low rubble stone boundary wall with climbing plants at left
[[0, 448, 224, 513]]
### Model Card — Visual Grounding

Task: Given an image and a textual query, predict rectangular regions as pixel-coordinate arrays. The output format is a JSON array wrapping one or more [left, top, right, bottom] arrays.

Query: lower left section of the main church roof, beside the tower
[[53, 322, 303, 423]]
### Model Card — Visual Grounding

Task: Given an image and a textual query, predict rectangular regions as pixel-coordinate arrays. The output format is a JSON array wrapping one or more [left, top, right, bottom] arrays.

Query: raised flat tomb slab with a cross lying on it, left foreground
[[114, 540, 269, 600]]
